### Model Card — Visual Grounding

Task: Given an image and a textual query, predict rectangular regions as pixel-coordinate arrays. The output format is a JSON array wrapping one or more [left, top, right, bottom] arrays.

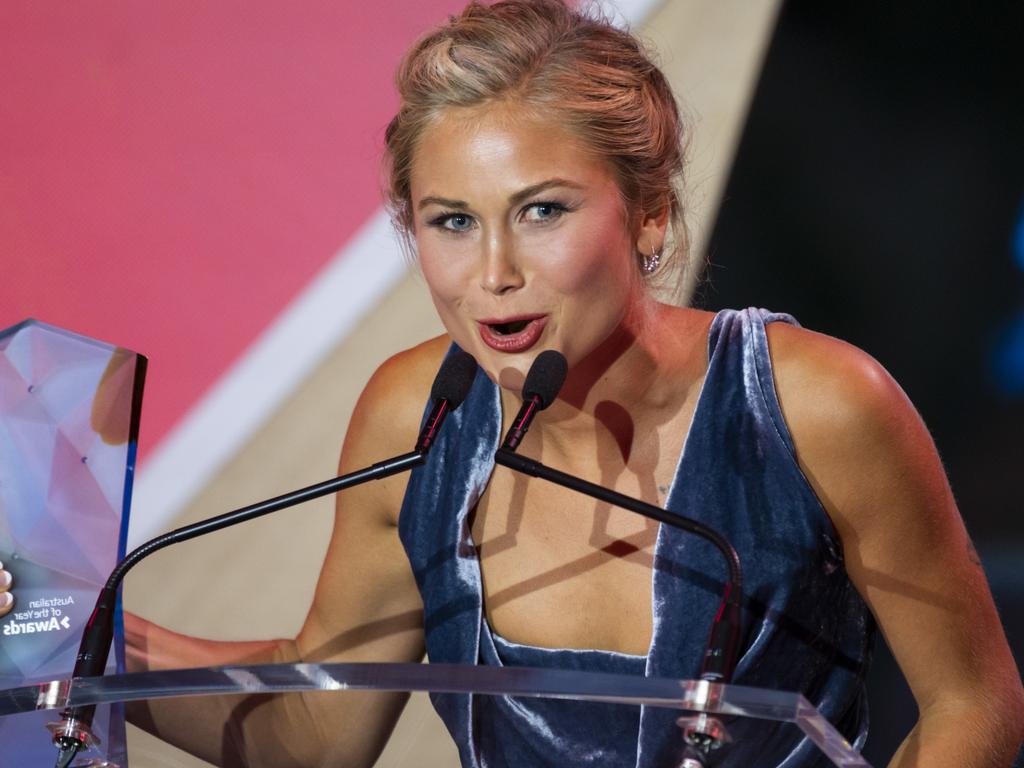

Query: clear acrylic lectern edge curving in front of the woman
[[0, 664, 869, 768]]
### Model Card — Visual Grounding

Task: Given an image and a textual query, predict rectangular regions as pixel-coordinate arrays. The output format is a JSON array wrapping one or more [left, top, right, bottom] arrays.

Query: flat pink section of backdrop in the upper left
[[0, 0, 462, 462]]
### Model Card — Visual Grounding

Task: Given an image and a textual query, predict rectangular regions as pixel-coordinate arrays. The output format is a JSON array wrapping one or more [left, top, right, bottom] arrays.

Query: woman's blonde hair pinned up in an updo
[[385, 0, 686, 276]]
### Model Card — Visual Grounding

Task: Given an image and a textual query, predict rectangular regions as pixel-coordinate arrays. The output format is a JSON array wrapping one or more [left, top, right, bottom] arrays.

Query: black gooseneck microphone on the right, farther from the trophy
[[495, 351, 743, 768]]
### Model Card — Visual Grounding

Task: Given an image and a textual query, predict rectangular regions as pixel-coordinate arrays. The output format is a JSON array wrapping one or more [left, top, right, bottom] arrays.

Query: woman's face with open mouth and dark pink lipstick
[[412, 106, 643, 389]]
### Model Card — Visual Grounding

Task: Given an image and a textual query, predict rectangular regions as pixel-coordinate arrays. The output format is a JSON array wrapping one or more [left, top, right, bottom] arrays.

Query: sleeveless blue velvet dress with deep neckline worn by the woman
[[398, 309, 874, 768]]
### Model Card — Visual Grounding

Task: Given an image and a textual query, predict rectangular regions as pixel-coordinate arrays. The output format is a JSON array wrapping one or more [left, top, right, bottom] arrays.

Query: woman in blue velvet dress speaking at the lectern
[[4, 0, 1024, 767]]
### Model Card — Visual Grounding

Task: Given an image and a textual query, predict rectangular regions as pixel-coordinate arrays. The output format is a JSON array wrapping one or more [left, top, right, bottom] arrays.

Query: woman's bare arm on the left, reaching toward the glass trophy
[[126, 341, 444, 768]]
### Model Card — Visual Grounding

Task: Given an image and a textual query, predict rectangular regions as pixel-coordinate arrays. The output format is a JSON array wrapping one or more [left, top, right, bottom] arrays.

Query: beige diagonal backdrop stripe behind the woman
[[125, 0, 779, 768]]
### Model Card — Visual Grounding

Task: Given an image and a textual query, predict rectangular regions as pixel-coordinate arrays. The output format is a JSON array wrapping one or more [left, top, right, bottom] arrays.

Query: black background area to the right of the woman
[[694, 0, 1024, 766]]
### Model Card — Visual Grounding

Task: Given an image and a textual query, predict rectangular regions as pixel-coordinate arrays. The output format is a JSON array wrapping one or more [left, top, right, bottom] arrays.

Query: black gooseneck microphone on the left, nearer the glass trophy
[[48, 347, 476, 768]]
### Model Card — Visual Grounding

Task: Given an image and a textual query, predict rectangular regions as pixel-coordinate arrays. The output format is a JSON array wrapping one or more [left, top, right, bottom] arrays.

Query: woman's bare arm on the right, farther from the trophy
[[769, 324, 1024, 768]]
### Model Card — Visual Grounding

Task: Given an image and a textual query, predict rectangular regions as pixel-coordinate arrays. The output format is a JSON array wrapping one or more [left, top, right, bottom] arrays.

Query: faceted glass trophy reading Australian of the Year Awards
[[0, 319, 146, 768]]
